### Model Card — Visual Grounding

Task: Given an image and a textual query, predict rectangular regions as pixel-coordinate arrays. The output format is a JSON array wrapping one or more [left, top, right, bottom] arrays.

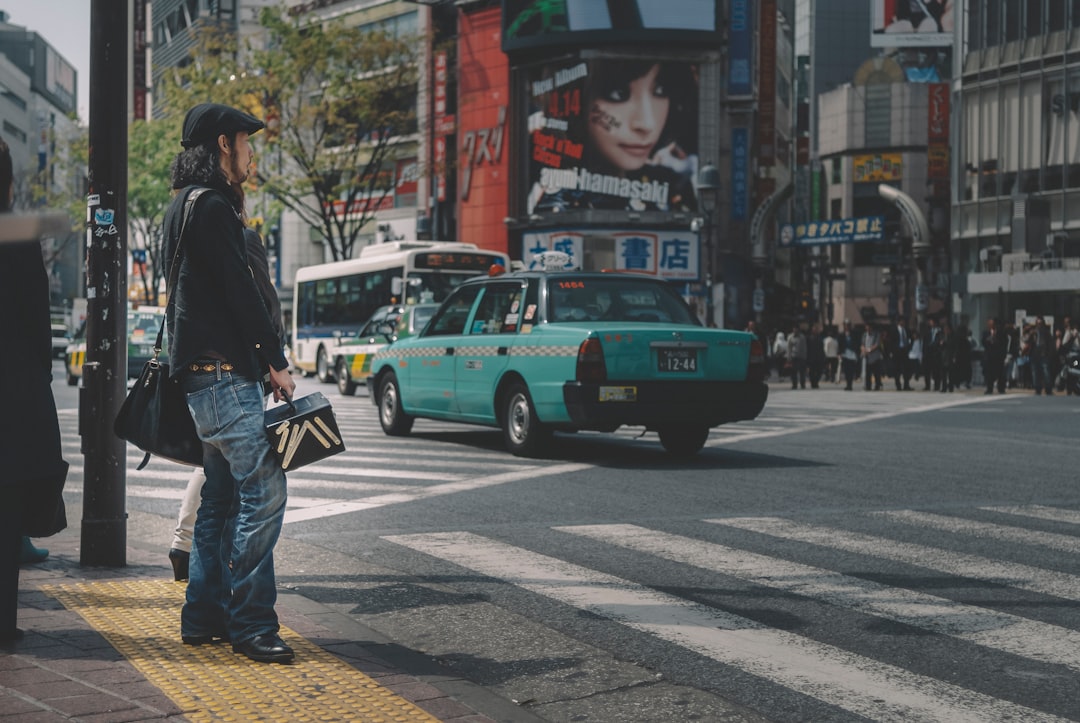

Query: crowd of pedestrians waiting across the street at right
[[746, 317, 1080, 394]]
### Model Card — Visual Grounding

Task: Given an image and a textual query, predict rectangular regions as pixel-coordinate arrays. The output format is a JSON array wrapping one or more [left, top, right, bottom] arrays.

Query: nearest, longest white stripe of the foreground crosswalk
[[382, 532, 1059, 723]]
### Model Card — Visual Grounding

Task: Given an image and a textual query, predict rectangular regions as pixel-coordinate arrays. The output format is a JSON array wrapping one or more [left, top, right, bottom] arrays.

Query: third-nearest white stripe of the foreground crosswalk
[[705, 518, 1080, 602]]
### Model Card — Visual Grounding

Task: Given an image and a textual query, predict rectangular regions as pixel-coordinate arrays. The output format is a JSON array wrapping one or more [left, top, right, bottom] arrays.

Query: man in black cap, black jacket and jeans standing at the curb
[[164, 104, 296, 662]]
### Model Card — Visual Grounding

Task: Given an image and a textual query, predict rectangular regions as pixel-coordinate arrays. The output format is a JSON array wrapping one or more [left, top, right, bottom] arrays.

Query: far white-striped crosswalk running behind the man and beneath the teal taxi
[[59, 390, 1000, 524]]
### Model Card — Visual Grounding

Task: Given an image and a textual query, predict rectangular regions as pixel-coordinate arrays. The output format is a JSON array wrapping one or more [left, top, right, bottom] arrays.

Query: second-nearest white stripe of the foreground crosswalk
[[553, 524, 1080, 670]]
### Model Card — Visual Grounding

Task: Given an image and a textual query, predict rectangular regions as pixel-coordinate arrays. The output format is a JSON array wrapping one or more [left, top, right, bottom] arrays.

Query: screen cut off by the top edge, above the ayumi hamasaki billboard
[[502, 0, 718, 51]]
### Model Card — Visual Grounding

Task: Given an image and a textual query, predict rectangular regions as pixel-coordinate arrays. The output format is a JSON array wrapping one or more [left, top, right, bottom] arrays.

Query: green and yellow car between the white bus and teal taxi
[[330, 304, 438, 397]]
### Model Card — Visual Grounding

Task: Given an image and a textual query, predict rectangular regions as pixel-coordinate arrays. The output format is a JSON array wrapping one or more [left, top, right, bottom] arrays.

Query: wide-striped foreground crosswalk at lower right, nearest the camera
[[382, 507, 1080, 722]]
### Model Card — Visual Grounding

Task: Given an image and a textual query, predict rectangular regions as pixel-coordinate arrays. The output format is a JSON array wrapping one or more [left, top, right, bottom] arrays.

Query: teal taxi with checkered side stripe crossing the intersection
[[367, 271, 768, 456]]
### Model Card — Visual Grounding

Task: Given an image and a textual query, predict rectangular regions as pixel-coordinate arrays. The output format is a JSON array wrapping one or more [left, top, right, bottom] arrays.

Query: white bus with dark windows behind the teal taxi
[[292, 241, 510, 381]]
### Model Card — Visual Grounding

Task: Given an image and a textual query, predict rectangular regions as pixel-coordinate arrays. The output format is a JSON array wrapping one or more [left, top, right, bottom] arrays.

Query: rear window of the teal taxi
[[548, 276, 700, 325]]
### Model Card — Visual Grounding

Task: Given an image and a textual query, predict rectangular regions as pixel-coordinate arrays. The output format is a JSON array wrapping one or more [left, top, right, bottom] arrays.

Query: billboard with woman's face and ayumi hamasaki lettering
[[524, 57, 698, 215]]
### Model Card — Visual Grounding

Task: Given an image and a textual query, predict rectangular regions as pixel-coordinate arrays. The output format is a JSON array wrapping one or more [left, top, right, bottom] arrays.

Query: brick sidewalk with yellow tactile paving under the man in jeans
[[0, 525, 541, 723]]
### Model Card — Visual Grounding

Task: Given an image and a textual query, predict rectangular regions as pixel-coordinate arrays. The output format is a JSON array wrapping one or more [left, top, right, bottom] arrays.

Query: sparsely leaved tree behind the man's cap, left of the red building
[[157, 6, 418, 259]]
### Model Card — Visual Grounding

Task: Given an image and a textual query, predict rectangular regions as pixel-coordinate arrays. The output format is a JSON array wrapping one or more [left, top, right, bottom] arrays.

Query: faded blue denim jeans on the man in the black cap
[[180, 372, 286, 643]]
